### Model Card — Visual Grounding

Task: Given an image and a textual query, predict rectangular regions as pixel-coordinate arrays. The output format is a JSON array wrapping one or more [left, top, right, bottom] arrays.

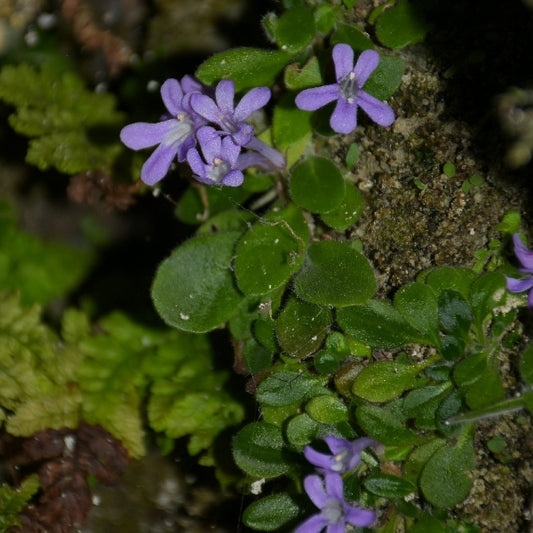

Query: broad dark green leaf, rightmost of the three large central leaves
[[294, 241, 376, 307]]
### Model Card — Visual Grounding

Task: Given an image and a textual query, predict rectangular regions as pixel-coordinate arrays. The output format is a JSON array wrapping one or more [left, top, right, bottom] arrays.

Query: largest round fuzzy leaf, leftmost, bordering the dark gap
[[152, 231, 242, 333]]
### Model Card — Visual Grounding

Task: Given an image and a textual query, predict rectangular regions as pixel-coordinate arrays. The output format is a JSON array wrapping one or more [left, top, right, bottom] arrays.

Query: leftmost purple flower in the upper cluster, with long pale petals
[[120, 76, 205, 185]]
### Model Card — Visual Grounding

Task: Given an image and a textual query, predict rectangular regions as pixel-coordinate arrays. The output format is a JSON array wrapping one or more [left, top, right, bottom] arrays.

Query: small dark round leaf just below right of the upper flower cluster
[[290, 157, 345, 213]]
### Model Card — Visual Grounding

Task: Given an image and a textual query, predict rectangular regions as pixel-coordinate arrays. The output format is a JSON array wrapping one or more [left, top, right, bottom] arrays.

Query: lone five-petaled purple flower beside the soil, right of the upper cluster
[[296, 44, 394, 133]]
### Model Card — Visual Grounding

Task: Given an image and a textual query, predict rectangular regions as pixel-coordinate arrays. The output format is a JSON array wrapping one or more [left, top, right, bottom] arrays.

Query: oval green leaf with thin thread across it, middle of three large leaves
[[234, 205, 309, 295]]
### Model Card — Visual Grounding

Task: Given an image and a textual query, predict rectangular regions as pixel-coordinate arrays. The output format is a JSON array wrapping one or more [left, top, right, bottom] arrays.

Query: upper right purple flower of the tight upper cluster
[[191, 80, 270, 146]]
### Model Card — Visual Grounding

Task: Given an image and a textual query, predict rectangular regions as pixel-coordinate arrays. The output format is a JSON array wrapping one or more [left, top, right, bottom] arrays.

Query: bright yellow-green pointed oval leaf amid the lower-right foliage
[[352, 361, 426, 403]]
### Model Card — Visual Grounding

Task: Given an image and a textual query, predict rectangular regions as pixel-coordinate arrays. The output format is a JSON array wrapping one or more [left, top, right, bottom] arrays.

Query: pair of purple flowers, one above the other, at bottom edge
[[294, 435, 377, 533]]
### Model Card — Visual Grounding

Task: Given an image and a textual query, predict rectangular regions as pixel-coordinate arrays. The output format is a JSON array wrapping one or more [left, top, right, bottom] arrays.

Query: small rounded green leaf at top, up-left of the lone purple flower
[[274, 6, 316, 54]]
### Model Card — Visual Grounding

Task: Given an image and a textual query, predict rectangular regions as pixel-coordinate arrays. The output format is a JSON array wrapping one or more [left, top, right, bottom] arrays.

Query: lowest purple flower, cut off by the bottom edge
[[294, 474, 376, 533]]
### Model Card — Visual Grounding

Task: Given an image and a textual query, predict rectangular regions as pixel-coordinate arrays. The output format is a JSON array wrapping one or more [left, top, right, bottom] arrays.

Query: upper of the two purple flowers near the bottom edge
[[304, 435, 377, 474]]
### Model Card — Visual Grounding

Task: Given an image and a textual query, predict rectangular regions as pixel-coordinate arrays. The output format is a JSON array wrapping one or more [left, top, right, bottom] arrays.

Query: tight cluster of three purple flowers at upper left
[[120, 76, 285, 187]]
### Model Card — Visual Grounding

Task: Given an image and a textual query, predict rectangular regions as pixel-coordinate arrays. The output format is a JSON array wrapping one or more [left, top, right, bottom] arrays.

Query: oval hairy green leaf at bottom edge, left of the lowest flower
[[242, 492, 300, 531]]
